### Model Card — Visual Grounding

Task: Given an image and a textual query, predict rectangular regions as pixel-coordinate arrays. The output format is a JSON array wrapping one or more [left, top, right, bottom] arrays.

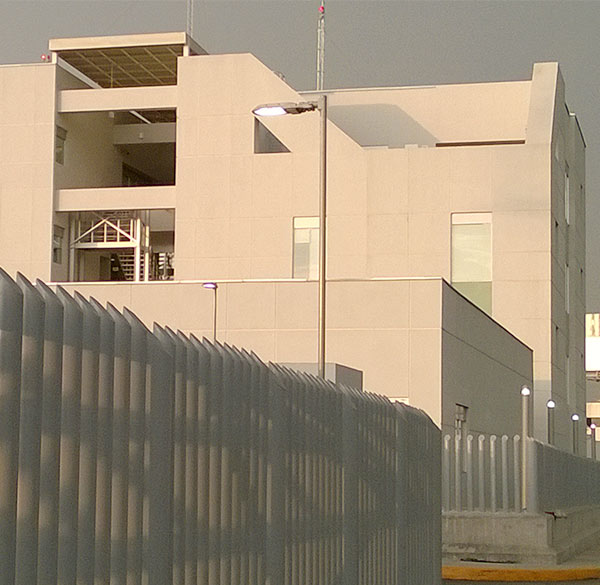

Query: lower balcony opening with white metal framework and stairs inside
[[59, 209, 175, 282]]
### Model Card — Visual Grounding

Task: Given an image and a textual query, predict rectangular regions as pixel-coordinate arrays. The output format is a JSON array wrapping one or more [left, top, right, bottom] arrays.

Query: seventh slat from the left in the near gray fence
[[107, 303, 131, 585]]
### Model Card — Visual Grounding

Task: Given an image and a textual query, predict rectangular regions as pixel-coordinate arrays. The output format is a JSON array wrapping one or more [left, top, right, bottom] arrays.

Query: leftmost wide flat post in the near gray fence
[[143, 325, 175, 585]]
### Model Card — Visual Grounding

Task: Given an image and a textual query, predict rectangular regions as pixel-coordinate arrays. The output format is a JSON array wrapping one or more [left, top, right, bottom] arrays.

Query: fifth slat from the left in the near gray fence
[[75, 293, 100, 585]]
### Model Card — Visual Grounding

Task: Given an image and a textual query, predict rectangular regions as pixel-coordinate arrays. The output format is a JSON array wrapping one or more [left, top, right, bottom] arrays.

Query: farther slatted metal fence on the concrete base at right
[[442, 435, 600, 513]]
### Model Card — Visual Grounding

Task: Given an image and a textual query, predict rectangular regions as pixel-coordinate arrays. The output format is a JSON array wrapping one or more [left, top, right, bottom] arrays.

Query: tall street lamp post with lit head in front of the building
[[252, 95, 327, 378]]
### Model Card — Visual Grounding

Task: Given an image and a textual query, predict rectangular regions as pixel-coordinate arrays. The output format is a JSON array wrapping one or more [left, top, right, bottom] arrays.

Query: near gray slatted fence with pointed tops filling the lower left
[[0, 270, 441, 585]]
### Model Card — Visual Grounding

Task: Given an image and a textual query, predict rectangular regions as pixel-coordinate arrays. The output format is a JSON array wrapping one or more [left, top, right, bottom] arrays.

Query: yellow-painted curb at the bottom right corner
[[442, 565, 600, 582]]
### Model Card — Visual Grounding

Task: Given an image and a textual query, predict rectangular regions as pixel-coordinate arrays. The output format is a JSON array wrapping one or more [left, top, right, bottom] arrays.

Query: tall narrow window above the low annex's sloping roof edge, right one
[[452, 213, 492, 313]]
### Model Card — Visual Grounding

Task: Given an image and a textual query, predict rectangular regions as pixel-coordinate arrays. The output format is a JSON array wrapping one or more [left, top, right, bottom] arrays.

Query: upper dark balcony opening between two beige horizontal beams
[[55, 109, 176, 189]]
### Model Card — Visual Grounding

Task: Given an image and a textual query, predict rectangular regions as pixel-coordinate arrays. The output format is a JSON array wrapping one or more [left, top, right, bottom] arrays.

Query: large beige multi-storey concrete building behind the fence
[[0, 33, 585, 446]]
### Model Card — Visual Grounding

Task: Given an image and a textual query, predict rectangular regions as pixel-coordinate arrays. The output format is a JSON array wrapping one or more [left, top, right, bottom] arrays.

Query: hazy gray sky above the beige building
[[0, 0, 600, 311]]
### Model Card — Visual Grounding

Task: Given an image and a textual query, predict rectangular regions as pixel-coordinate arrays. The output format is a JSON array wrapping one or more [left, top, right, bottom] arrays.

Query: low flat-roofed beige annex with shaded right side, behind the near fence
[[62, 278, 532, 434]]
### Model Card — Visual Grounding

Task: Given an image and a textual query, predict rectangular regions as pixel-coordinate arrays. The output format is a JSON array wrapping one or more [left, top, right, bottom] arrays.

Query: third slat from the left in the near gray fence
[[36, 280, 64, 585]]
